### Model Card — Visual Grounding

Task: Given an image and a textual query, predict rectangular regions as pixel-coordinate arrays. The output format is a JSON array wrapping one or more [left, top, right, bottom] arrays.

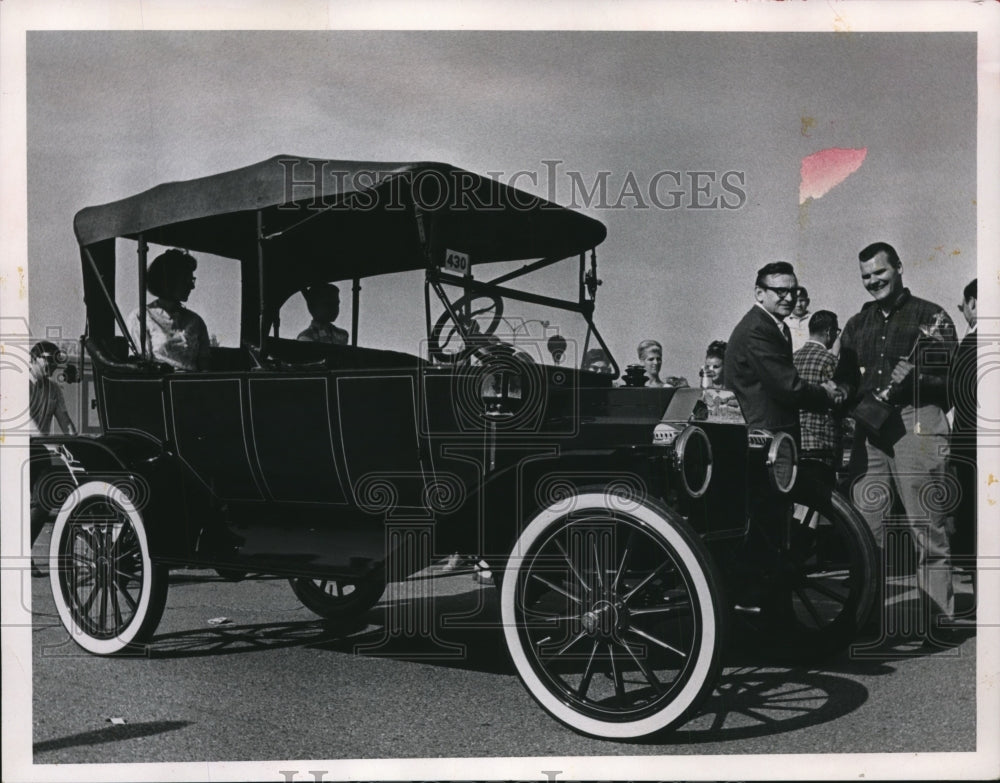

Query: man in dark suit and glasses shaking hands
[[724, 261, 841, 443]]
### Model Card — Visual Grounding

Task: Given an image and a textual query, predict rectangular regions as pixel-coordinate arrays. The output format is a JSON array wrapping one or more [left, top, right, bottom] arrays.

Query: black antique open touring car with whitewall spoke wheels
[[39, 156, 876, 739]]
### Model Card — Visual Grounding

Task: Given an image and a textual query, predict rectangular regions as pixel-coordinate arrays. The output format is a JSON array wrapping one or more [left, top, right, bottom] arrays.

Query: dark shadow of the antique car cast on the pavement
[[90, 583, 912, 746]]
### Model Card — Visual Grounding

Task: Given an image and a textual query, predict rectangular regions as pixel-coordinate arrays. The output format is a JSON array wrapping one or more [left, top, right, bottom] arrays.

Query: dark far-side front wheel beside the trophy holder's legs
[[754, 480, 878, 660]]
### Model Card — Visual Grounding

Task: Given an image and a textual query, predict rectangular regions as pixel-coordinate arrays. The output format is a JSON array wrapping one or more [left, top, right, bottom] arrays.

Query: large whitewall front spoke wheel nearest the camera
[[500, 492, 726, 739]]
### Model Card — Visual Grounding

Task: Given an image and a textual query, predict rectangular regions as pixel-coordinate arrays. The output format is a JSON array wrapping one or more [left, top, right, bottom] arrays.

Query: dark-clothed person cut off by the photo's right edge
[[948, 280, 979, 584]]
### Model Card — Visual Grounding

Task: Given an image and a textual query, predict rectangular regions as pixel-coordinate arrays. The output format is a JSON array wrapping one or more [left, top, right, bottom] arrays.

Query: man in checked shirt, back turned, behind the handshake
[[786, 310, 844, 486]]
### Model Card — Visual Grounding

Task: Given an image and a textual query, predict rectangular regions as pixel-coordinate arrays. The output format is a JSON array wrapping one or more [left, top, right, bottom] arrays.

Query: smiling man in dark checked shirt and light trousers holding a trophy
[[834, 242, 955, 643]]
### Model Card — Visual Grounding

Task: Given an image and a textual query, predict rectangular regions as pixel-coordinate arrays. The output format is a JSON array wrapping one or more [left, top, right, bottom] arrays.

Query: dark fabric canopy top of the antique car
[[74, 155, 606, 306]]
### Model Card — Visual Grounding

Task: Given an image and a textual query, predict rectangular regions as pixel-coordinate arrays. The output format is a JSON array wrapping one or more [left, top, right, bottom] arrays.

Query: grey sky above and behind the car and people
[[21, 26, 977, 378]]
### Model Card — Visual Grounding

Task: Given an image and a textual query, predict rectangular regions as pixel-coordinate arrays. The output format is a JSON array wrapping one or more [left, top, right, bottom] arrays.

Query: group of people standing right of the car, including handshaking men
[[625, 248, 978, 643]]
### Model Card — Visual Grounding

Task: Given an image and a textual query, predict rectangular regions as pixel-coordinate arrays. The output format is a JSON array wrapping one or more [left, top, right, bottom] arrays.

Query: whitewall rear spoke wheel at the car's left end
[[49, 481, 168, 655]]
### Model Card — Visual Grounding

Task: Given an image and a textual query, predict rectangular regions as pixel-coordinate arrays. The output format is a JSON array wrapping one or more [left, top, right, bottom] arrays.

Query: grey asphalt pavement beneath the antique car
[[25, 544, 976, 779]]
